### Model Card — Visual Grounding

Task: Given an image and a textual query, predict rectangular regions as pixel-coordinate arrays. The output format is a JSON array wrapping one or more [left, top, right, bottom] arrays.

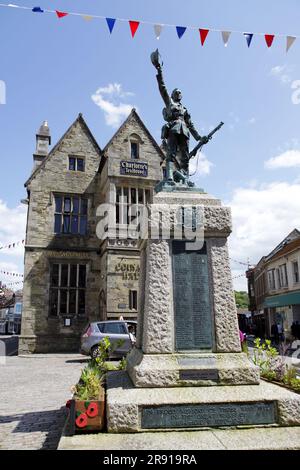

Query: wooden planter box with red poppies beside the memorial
[[67, 387, 105, 435]]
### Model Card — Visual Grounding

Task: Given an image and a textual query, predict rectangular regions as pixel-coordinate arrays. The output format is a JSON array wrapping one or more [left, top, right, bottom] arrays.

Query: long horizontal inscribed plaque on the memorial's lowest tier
[[141, 402, 277, 429]]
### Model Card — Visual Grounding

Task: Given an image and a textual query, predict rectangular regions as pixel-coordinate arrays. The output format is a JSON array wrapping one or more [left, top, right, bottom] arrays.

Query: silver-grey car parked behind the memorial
[[80, 320, 136, 359]]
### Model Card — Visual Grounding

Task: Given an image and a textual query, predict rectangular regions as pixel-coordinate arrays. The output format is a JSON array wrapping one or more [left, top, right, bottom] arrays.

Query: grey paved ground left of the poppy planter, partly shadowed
[[0, 354, 84, 450]]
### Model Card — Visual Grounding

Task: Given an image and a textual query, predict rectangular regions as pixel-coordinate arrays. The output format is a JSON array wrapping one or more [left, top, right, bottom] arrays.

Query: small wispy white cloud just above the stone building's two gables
[[91, 83, 134, 128]]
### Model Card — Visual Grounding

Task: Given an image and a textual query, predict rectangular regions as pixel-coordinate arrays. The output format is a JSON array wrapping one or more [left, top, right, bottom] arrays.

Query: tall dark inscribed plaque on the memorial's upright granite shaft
[[173, 240, 212, 351]]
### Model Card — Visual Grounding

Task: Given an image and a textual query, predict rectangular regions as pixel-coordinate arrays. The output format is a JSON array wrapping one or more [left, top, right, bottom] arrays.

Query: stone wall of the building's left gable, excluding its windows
[[19, 116, 101, 352]]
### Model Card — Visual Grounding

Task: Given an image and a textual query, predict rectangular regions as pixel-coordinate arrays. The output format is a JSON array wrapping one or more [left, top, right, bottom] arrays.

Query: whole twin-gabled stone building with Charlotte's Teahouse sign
[[19, 109, 164, 353]]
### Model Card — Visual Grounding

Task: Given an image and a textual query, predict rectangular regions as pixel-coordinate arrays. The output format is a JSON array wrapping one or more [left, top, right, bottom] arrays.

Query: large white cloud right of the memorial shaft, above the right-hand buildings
[[226, 182, 300, 290]]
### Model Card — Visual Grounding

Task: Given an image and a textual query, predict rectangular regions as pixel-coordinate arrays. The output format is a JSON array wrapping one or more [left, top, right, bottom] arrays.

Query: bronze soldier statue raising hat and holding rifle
[[151, 49, 223, 186]]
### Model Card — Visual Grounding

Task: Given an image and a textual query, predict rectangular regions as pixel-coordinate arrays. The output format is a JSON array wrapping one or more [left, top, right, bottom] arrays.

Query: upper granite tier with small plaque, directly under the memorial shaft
[[127, 349, 259, 388]]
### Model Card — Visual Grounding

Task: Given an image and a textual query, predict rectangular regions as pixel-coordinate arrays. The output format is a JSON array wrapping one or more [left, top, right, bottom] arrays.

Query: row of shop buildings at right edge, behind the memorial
[[247, 229, 300, 338]]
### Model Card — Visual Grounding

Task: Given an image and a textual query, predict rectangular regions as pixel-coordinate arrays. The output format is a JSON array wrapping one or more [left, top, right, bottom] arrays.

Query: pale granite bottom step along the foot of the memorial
[[58, 426, 300, 451]]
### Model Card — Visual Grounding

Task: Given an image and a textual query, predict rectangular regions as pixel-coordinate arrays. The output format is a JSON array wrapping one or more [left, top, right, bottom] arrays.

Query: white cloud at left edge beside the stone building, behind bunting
[[0, 200, 27, 289]]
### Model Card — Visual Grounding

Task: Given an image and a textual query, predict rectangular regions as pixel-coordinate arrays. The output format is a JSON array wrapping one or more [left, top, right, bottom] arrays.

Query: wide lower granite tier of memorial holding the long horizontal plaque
[[107, 371, 300, 433]]
